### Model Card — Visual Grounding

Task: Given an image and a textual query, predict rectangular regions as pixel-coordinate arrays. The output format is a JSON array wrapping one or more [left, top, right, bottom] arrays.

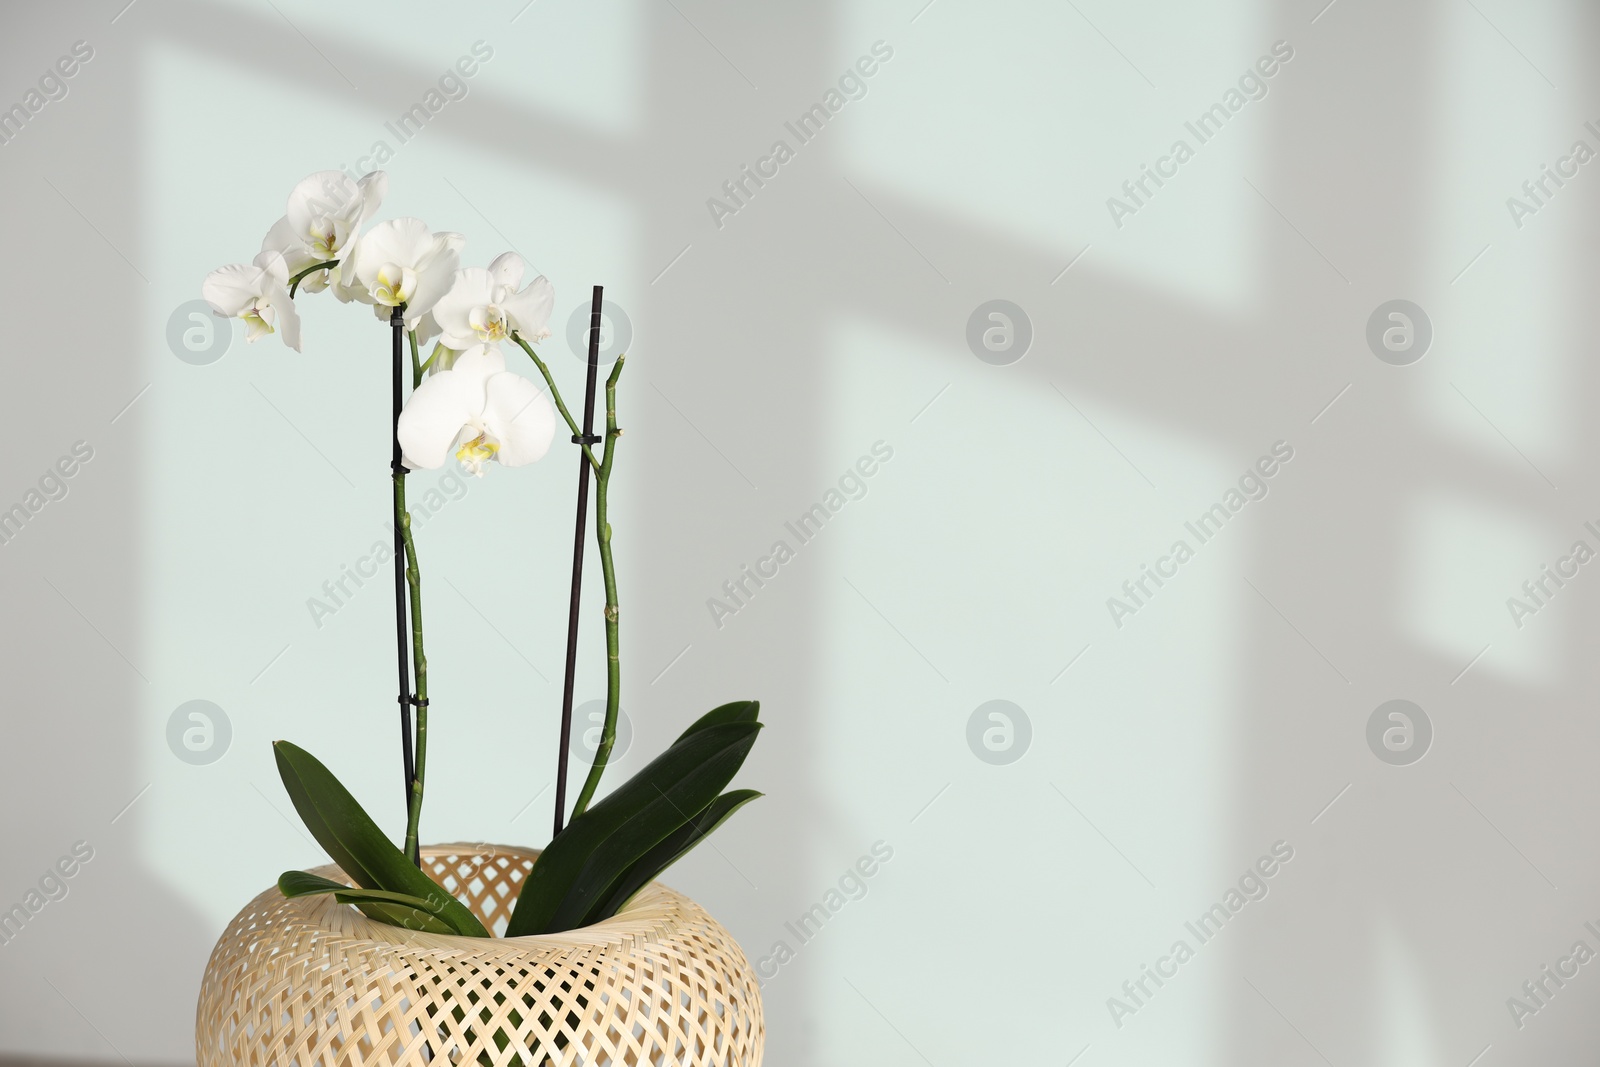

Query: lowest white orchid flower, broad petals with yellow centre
[[397, 344, 555, 478]]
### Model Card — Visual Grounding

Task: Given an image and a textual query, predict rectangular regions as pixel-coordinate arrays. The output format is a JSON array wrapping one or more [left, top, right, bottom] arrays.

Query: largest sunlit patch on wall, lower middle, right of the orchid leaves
[[812, 310, 1251, 1062]]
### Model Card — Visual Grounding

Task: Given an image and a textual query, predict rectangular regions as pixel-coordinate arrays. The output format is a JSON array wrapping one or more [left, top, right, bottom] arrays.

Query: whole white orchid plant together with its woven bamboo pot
[[197, 171, 762, 1065]]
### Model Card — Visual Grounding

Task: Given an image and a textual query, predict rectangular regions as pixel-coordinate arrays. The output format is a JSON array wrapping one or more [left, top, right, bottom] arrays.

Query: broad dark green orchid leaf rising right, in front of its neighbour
[[506, 720, 762, 937]]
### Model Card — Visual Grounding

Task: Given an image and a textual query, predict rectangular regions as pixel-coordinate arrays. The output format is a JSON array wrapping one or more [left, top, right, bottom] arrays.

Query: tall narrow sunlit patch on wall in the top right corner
[[1420, 5, 1568, 470]]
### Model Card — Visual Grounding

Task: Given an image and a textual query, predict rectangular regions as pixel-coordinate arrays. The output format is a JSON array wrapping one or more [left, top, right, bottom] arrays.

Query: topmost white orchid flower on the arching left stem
[[261, 171, 389, 301]]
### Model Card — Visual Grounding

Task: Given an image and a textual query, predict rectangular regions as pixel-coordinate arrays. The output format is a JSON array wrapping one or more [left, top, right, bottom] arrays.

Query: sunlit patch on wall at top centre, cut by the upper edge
[[838, 3, 1273, 309]]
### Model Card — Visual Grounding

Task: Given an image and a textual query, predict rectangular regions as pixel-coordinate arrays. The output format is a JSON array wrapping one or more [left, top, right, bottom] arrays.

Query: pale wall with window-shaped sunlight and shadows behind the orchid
[[0, 0, 1600, 1067]]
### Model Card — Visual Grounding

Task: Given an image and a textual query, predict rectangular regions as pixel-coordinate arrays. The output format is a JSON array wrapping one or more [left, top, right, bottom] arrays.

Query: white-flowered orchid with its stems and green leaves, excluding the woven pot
[[202, 171, 760, 921]]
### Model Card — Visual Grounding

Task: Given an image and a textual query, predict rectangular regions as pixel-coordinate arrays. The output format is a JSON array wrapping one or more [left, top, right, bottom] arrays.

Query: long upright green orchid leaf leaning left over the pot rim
[[272, 741, 490, 937]]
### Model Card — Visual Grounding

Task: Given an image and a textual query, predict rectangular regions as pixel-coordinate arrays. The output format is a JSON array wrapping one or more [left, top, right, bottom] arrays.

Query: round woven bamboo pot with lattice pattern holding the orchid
[[195, 845, 765, 1067]]
